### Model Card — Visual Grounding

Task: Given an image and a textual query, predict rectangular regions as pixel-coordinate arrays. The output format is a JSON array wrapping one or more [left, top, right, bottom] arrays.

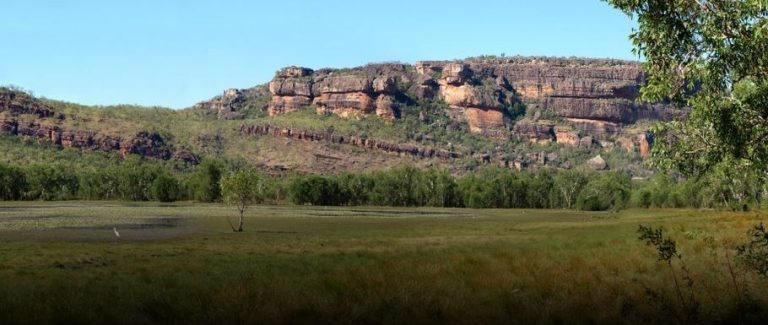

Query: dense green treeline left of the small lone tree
[[0, 157, 224, 202]]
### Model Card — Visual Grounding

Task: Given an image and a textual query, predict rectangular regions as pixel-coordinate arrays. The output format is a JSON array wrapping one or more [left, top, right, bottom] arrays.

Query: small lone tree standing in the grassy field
[[221, 170, 262, 232]]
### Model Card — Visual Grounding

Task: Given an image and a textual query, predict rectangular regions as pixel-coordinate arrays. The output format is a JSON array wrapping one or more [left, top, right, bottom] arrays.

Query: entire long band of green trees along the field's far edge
[[0, 157, 766, 210]]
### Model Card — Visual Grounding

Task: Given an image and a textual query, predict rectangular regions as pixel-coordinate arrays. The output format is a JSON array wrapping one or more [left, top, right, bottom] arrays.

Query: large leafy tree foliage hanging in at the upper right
[[605, 0, 768, 175]]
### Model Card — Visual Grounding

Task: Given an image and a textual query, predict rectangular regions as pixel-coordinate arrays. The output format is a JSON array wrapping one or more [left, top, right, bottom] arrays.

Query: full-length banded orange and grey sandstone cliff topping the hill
[[234, 57, 684, 154]]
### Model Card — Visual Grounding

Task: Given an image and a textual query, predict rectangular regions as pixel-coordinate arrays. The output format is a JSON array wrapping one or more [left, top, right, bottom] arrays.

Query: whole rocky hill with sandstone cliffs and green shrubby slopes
[[0, 57, 684, 176]]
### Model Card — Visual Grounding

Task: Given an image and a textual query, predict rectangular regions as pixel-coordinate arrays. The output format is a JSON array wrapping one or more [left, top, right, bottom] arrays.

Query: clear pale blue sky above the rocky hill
[[0, 0, 637, 108]]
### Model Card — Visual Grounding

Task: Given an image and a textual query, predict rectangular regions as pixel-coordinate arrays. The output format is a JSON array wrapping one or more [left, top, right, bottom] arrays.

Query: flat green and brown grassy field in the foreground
[[0, 202, 768, 324]]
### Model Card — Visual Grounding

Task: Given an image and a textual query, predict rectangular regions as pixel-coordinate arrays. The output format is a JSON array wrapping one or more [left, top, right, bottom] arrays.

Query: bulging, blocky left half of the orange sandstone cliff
[[268, 63, 514, 138]]
